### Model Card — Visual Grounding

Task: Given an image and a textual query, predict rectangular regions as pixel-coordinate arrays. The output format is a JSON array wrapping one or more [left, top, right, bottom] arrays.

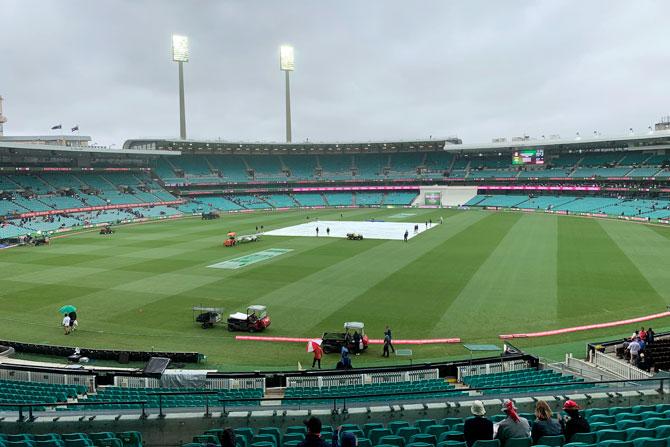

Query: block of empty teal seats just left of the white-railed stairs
[[463, 369, 594, 394]]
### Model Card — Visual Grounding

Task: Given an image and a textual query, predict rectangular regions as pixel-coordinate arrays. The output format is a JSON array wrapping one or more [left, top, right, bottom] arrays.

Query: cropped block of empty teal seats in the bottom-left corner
[[0, 431, 143, 447]]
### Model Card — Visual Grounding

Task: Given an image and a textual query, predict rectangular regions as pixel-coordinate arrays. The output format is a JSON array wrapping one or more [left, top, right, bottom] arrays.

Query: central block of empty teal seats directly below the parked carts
[[284, 379, 462, 405]]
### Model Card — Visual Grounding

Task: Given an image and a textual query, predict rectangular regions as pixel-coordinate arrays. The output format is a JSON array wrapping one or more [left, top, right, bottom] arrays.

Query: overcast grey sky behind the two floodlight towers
[[0, 0, 670, 145]]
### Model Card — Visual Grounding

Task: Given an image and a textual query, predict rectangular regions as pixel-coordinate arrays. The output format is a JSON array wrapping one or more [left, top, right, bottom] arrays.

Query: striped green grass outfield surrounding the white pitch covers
[[0, 208, 670, 370]]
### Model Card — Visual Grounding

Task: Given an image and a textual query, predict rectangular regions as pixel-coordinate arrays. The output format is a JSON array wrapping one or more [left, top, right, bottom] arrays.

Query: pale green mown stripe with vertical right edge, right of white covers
[[443, 214, 558, 340]]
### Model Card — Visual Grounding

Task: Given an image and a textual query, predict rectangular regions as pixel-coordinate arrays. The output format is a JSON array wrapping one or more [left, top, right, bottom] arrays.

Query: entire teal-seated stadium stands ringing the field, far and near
[[0, 131, 670, 447]]
